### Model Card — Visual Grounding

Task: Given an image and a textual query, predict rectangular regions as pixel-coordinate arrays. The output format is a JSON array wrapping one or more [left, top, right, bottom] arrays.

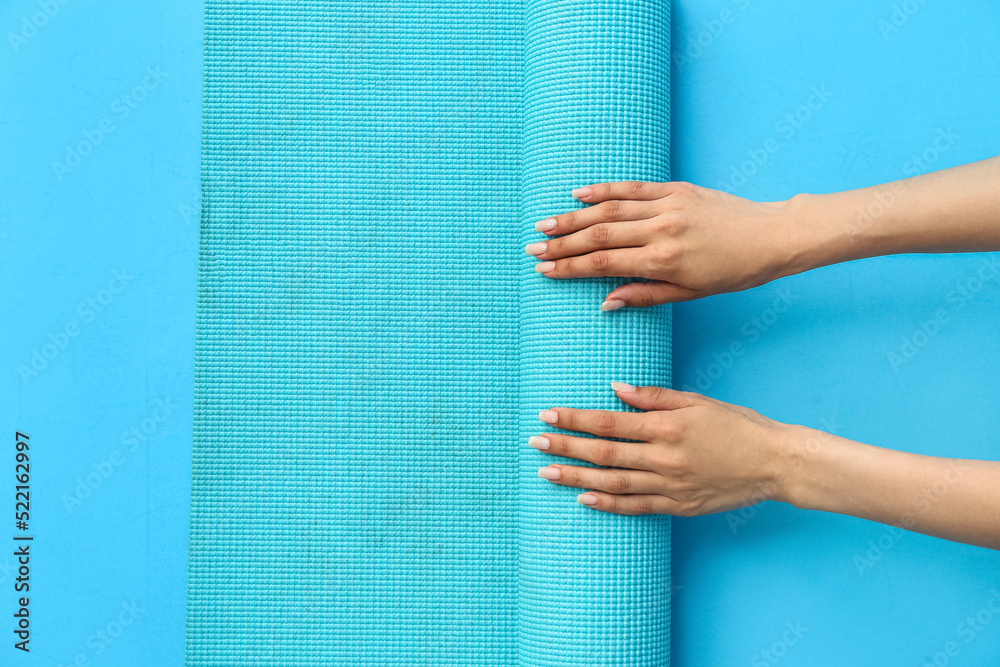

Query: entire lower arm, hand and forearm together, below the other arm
[[529, 383, 1000, 549]]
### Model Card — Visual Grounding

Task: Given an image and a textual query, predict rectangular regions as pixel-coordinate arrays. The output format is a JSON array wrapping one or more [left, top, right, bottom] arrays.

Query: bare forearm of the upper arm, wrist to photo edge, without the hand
[[782, 157, 1000, 275]]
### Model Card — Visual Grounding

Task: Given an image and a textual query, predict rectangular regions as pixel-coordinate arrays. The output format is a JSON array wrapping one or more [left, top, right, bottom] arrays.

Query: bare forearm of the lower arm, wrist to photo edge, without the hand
[[776, 427, 1000, 549]]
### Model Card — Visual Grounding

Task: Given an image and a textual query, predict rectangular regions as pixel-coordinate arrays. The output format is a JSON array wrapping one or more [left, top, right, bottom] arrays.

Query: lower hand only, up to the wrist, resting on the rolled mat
[[530, 383, 802, 516]]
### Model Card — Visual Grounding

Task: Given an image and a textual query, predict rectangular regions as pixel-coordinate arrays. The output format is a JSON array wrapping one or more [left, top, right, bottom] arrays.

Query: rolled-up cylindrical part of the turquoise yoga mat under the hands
[[518, 0, 671, 667]]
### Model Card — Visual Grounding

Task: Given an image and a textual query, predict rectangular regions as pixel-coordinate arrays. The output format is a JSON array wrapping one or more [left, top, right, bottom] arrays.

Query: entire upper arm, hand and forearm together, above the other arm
[[525, 157, 1000, 310]]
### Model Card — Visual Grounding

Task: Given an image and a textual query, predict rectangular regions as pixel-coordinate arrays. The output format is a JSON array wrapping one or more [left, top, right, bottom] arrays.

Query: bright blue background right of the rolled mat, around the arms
[[671, 0, 1000, 667]]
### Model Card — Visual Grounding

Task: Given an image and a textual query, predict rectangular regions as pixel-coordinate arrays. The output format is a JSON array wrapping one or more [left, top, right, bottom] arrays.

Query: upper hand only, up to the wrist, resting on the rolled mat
[[525, 181, 809, 310]]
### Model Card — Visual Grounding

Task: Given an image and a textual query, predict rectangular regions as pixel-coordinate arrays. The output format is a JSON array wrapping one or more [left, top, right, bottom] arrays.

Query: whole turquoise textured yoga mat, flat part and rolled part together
[[187, 0, 671, 666]]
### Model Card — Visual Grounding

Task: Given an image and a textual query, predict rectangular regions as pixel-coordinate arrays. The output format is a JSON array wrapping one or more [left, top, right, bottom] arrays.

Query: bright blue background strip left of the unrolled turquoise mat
[[0, 0, 202, 665]]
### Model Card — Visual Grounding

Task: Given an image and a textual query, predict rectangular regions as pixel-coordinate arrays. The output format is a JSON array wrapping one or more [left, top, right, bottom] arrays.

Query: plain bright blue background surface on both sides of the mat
[[0, 0, 1000, 666]]
